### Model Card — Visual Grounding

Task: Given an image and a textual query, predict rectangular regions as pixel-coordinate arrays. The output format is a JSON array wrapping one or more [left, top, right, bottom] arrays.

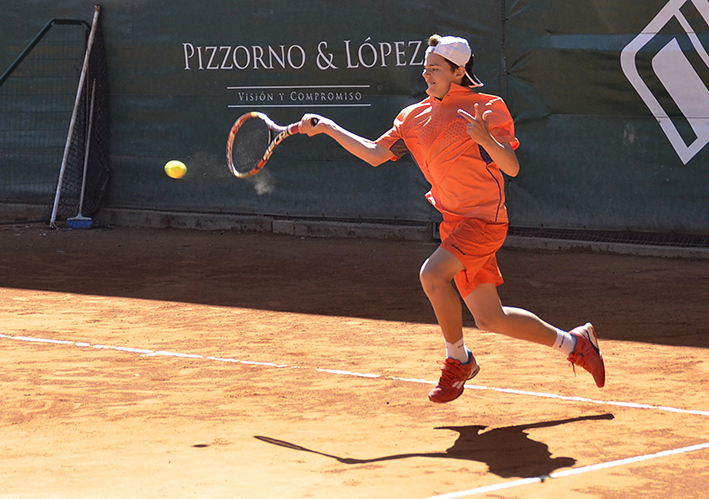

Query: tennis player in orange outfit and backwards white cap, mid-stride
[[300, 35, 605, 403]]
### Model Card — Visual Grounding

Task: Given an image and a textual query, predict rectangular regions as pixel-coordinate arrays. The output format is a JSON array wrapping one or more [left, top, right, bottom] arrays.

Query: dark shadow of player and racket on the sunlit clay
[[254, 414, 614, 478]]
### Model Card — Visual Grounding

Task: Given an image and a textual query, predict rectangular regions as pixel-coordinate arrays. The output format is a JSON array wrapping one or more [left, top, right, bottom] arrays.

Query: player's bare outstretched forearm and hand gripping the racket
[[300, 114, 397, 166]]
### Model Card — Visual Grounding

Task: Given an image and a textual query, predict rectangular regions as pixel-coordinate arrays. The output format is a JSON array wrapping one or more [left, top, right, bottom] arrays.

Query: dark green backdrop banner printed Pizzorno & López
[[0, 0, 709, 233]]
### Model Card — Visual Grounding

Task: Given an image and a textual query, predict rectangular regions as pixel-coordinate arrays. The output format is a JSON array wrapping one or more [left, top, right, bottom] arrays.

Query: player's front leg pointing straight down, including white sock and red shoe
[[419, 248, 480, 403]]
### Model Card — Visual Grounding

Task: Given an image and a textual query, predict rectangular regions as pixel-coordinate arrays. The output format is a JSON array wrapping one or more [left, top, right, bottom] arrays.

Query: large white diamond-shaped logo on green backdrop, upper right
[[620, 0, 709, 165]]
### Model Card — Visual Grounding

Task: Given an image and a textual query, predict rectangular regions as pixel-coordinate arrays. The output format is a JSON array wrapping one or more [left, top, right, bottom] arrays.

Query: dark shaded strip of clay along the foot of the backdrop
[[0, 226, 709, 348]]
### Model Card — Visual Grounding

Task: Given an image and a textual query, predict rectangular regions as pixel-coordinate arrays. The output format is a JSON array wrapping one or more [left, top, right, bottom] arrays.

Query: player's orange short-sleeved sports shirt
[[376, 83, 519, 222]]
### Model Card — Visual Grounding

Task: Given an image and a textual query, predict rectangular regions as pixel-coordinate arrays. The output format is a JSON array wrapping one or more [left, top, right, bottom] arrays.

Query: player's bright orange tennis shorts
[[440, 215, 508, 298]]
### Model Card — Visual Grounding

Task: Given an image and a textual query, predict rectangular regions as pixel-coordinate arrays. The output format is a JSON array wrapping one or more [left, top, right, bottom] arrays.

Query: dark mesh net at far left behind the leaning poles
[[0, 13, 108, 222]]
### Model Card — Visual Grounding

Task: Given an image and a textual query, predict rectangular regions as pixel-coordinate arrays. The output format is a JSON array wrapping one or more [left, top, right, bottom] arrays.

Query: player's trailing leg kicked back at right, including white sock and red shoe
[[464, 284, 606, 387]]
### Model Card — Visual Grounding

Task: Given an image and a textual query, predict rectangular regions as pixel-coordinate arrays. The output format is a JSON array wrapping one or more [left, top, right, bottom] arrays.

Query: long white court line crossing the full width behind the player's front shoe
[[0, 334, 709, 417]]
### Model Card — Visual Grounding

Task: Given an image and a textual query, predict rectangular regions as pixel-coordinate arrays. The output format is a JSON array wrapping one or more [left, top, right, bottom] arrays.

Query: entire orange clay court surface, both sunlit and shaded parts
[[0, 226, 709, 499]]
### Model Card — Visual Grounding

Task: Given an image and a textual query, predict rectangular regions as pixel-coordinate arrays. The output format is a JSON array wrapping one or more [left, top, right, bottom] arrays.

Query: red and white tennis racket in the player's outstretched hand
[[226, 111, 317, 178]]
